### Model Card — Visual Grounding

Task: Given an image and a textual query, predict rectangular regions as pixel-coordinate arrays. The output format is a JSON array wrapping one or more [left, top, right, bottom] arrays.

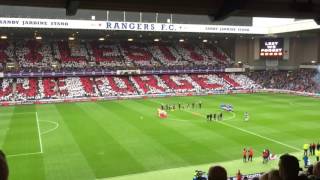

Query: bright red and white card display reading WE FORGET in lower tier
[[0, 73, 260, 102]]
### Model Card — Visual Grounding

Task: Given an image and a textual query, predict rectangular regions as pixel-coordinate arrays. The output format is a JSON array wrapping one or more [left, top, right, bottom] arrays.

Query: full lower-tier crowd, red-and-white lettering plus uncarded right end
[[0, 70, 320, 101]]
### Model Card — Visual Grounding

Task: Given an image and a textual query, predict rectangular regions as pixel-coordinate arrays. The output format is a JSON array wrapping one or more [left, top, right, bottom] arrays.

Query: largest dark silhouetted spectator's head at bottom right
[[279, 154, 303, 180]]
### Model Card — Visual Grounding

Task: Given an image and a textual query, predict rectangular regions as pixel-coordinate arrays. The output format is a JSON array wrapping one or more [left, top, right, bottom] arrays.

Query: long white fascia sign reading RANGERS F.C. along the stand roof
[[0, 17, 268, 34]]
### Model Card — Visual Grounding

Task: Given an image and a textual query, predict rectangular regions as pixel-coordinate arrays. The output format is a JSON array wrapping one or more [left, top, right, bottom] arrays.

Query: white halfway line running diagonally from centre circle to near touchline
[[186, 111, 301, 151]]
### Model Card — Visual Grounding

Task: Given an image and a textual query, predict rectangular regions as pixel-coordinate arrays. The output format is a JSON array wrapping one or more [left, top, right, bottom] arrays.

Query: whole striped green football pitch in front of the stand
[[0, 94, 320, 180]]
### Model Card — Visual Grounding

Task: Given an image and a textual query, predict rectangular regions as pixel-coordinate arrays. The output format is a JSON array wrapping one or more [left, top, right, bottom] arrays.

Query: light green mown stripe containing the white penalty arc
[[37, 104, 95, 180]]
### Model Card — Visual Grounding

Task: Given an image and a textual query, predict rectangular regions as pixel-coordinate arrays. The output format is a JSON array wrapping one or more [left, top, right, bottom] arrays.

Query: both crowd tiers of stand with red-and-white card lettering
[[0, 39, 319, 105]]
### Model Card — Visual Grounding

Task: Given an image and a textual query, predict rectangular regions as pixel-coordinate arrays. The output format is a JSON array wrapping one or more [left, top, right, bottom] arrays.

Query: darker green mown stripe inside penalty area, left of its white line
[[4, 105, 46, 180]]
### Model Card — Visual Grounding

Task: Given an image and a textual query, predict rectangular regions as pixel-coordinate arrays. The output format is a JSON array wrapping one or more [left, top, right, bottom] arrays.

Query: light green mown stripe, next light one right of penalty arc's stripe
[[80, 102, 187, 171]]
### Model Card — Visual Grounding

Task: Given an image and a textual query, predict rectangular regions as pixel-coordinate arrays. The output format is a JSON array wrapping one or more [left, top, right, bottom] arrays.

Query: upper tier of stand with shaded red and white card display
[[0, 40, 232, 72]]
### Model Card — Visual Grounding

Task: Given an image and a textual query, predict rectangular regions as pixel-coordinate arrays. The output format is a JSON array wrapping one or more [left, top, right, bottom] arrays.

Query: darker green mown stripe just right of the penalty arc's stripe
[[57, 104, 144, 177]]
